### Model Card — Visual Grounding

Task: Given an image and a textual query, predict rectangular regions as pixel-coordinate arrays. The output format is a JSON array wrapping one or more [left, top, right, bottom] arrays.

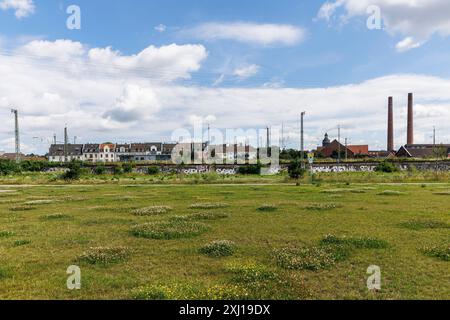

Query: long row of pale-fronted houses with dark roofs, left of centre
[[48, 142, 258, 163]]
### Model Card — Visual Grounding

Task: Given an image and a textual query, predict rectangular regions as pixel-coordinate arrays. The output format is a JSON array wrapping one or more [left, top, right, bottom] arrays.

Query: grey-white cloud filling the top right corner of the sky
[[318, 0, 450, 52]]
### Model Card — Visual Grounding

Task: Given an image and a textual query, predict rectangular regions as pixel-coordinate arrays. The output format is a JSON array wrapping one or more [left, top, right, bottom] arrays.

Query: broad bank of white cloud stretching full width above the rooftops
[[0, 38, 450, 153]]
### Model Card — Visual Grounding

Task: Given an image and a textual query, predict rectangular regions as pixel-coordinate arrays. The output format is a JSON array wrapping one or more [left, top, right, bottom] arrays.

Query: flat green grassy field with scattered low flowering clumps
[[0, 182, 450, 299]]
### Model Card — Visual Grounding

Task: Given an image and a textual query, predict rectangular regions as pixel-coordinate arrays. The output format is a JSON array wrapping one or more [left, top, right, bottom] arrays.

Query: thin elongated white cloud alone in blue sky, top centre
[[185, 22, 306, 46]]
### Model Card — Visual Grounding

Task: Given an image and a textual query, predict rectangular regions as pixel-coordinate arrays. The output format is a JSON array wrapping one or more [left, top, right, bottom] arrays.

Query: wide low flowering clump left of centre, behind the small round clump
[[131, 220, 209, 240]]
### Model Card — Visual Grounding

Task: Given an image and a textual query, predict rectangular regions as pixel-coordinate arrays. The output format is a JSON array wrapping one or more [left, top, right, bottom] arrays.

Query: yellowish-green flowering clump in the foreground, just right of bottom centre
[[227, 263, 277, 284]]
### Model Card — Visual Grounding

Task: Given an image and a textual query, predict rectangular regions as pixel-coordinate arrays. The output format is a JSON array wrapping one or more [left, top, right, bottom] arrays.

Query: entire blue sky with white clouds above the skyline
[[0, 0, 450, 154]]
